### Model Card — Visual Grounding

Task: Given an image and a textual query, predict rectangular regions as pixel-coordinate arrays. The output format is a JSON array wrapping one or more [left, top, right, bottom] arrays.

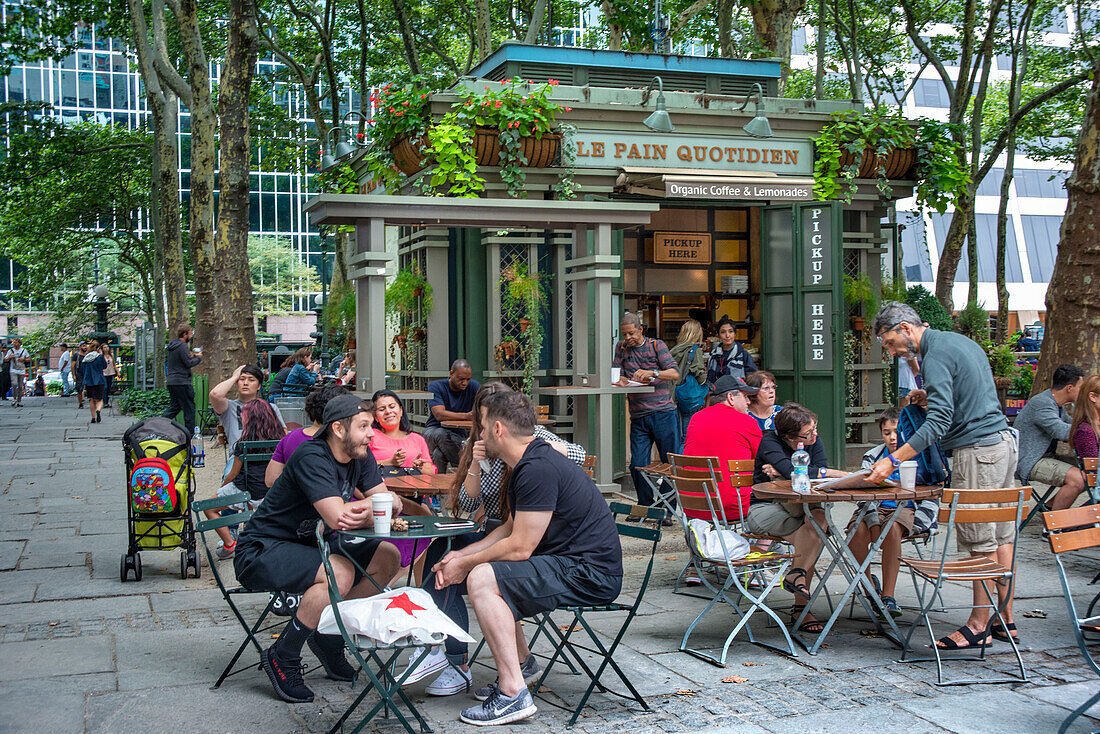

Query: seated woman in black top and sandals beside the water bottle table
[[745, 403, 847, 634]]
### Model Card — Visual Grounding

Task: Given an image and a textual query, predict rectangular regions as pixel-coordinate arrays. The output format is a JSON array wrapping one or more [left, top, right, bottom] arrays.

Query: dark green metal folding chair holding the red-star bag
[[316, 522, 432, 734]]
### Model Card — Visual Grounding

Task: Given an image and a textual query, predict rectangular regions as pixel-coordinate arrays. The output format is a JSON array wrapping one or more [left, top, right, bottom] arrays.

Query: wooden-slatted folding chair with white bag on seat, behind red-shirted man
[[669, 453, 798, 667]]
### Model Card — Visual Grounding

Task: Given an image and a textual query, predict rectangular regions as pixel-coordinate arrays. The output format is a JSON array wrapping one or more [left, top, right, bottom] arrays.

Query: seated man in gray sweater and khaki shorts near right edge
[[1013, 364, 1086, 510]]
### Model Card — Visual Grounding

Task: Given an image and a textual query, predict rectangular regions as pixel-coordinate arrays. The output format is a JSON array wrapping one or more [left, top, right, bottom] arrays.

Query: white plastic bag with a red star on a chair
[[317, 587, 475, 645]]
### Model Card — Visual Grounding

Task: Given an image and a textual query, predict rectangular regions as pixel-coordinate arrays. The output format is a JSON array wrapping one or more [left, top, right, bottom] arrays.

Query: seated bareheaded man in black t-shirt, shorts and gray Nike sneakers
[[432, 393, 623, 725]]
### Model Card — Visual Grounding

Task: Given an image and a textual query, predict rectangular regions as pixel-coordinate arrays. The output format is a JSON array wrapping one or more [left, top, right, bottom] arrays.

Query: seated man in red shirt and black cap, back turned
[[684, 374, 762, 521]]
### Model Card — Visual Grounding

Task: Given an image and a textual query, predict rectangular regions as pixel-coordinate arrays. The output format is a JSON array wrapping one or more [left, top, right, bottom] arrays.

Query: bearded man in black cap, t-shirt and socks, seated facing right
[[233, 395, 400, 703]]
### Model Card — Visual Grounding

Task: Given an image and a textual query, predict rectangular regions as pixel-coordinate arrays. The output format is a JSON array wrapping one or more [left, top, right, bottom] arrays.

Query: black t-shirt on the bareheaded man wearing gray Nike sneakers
[[508, 438, 623, 577]]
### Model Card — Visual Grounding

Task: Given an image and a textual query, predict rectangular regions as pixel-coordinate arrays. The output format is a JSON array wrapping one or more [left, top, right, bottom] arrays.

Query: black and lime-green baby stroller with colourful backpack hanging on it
[[119, 416, 199, 582]]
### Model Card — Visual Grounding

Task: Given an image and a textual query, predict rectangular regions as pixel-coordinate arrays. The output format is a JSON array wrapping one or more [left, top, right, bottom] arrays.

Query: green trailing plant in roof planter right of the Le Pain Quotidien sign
[[814, 108, 970, 213]]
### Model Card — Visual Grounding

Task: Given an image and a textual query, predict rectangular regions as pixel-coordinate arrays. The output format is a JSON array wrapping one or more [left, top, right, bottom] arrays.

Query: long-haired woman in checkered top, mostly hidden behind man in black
[[405, 382, 587, 695]]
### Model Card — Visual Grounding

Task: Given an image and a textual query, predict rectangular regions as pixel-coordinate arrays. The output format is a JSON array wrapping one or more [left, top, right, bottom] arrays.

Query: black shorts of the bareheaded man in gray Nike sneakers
[[490, 556, 623, 622]]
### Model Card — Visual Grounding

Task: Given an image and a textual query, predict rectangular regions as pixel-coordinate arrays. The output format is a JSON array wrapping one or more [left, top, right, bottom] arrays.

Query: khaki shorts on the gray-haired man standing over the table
[[952, 434, 1020, 554]]
